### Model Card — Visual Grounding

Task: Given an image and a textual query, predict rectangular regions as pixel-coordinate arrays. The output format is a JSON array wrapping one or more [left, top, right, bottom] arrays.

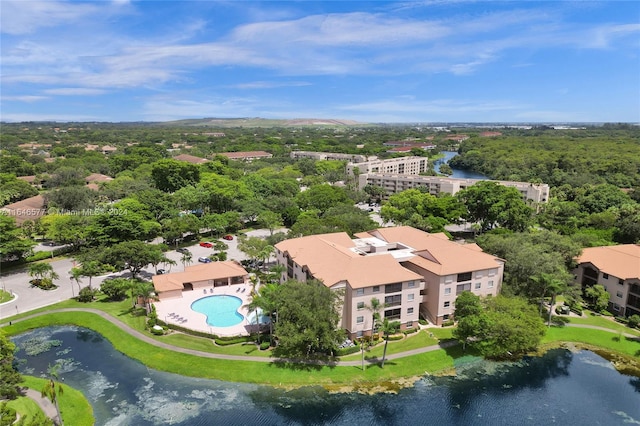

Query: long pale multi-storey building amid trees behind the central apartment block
[[358, 173, 549, 203]]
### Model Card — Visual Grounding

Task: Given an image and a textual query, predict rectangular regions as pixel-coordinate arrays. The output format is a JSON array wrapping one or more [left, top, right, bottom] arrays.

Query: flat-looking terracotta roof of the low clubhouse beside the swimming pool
[[152, 260, 248, 293]]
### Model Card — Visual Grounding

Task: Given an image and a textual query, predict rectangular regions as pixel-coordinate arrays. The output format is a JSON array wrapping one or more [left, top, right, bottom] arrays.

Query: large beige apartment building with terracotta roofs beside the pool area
[[275, 226, 504, 337]]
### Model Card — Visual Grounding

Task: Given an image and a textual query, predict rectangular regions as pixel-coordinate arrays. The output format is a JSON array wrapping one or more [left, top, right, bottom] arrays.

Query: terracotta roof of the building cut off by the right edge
[[577, 244, 640, 280]]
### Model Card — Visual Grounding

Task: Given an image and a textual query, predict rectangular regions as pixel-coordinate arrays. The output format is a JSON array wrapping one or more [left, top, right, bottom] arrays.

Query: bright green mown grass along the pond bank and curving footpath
[[3, 301, 640, 424]]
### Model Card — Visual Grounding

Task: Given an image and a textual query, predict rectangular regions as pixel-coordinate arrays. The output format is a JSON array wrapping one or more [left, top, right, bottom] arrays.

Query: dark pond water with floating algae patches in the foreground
[[12, 326, 640, 426]]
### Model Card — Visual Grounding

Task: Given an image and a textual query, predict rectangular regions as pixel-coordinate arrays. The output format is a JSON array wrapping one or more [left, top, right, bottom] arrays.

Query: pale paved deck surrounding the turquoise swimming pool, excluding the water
[[154, 283, 251, 336]]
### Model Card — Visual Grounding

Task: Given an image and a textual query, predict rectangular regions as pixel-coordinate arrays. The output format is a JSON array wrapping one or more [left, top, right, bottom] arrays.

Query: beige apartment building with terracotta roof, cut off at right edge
[[575, 244, 640, 317]]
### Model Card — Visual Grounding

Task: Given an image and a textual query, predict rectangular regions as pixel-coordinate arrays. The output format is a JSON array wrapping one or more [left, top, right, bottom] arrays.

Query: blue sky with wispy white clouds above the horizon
[[0, 0, 640, 123]]
